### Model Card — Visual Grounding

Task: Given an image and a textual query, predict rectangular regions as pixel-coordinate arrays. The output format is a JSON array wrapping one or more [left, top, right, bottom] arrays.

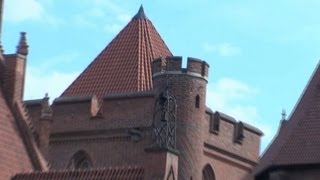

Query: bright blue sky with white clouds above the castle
[[2, 0, 320, 152]]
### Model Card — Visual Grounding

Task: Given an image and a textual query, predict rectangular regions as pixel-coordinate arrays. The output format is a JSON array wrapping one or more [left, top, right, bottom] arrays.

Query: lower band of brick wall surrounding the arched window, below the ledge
[[48, 129, 149, 169]]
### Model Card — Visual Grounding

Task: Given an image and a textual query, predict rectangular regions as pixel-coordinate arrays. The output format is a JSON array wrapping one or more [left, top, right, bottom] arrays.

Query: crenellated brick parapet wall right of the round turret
[[205, 108, 263, 165]]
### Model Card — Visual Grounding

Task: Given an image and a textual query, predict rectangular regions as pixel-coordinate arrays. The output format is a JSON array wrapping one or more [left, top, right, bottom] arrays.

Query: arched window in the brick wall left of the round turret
[[68, 150, 92, 169]]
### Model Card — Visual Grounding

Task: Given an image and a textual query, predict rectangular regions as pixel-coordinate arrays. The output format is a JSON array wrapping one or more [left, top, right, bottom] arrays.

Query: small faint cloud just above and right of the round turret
[[202, 43, 241, 56]]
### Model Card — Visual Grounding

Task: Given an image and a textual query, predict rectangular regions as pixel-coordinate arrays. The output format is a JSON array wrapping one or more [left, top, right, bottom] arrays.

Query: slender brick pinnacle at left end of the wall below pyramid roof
[[39, 93, 52, 157]]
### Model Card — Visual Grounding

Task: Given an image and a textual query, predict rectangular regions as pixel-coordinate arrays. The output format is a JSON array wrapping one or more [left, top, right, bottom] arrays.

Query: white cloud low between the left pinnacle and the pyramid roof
[[24, 67, 79, 100]]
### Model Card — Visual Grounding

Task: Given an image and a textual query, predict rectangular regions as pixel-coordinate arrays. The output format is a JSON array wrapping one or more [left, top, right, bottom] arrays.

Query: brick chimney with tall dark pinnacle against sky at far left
[[3, 32, 28, 105]]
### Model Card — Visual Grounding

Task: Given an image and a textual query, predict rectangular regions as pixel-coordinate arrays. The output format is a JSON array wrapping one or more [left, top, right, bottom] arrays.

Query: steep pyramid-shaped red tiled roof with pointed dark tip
[[61, 7, 172, 98]]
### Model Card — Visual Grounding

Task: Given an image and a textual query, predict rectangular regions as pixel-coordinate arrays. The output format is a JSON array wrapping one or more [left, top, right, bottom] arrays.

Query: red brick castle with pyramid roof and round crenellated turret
[[0, 1, 320, 180]]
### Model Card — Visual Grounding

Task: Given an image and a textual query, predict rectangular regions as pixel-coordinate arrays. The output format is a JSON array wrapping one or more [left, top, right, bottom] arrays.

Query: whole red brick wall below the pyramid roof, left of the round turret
[[48, 96, 154, 169]]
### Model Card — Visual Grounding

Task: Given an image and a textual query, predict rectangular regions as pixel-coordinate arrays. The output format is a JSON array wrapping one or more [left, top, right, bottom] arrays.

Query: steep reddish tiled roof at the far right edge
[[255, 61, 320, 175]]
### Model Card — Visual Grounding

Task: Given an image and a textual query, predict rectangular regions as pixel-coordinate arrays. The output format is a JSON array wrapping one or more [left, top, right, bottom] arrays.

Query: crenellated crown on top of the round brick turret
[[152, 56, 209, 80]]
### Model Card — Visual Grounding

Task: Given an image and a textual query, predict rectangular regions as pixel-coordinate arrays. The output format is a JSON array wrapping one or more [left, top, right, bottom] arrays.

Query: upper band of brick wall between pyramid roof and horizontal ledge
[[52, 97, 154, 133]]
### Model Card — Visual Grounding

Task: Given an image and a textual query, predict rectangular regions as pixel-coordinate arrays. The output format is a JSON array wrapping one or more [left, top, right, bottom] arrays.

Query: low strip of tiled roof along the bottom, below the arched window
[[11, 167, 144, 180]]
